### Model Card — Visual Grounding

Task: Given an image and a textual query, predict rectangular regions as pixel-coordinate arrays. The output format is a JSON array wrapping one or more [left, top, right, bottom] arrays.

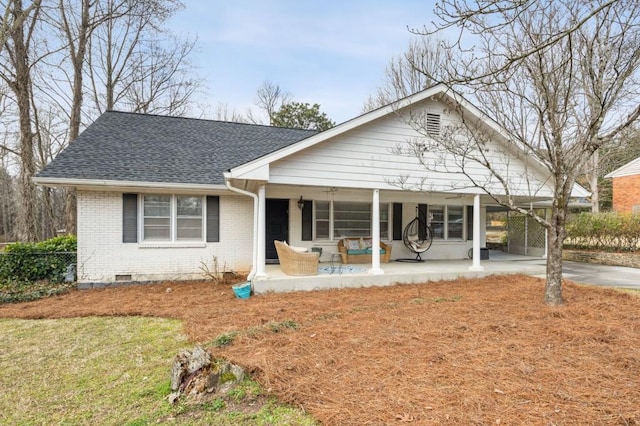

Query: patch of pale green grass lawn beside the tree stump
[[0, 317, 315, 425]]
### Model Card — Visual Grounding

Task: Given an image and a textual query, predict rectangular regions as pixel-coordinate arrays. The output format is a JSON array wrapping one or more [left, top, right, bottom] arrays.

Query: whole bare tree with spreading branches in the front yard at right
[[402, 0, 640, 305]]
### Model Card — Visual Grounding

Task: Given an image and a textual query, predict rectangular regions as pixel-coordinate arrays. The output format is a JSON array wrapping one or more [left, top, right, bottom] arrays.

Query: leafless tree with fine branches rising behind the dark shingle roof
[[88, 0, 202, 115]]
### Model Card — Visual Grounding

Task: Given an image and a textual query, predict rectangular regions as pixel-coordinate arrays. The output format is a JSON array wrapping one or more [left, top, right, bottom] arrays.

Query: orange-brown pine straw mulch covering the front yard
[[0, 275, 640, 425]]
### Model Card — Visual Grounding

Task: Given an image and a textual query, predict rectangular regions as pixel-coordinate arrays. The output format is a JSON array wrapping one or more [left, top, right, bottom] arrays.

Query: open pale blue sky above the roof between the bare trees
[[169, 0, 434, 123]]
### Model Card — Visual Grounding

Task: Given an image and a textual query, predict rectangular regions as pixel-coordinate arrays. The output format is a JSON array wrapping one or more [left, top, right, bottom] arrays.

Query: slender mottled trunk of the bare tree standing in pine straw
[[544, 207, 566, 306]]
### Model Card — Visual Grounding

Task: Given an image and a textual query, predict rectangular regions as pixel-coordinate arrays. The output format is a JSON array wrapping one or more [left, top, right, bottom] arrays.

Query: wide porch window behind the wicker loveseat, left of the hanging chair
[[314, 201, 390, 240]]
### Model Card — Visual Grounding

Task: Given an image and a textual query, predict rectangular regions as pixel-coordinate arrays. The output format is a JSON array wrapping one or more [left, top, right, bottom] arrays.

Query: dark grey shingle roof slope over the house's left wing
[[38, 111, 317, 185]]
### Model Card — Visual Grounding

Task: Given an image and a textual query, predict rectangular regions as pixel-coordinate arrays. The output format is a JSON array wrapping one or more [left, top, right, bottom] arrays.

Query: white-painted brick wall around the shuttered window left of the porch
[[77, 191, 253, 283]]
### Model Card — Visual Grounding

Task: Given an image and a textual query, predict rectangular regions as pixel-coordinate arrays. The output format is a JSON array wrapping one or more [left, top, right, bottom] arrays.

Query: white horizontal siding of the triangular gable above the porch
[[269, 99, 551, 197]]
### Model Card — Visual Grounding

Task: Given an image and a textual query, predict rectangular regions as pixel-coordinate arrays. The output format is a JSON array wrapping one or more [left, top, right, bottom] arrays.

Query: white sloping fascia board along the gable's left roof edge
[[229, 84, 447, 179]]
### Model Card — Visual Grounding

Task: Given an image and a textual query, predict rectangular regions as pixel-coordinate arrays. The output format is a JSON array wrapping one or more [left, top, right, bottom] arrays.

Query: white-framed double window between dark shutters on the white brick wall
[[141, 195, 204, 241]]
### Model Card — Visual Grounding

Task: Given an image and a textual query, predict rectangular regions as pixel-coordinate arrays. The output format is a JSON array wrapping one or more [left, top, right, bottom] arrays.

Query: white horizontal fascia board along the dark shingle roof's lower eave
[[32, 177, 228, 192]]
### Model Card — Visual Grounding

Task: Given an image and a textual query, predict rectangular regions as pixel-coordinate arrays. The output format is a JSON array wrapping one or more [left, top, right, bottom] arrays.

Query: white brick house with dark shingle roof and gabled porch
[[35, 85, 576, 283]]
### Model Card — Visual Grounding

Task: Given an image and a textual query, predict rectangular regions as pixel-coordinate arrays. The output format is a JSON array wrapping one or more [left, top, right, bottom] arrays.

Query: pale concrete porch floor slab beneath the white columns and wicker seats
[[253, 250, 546, 294]]
